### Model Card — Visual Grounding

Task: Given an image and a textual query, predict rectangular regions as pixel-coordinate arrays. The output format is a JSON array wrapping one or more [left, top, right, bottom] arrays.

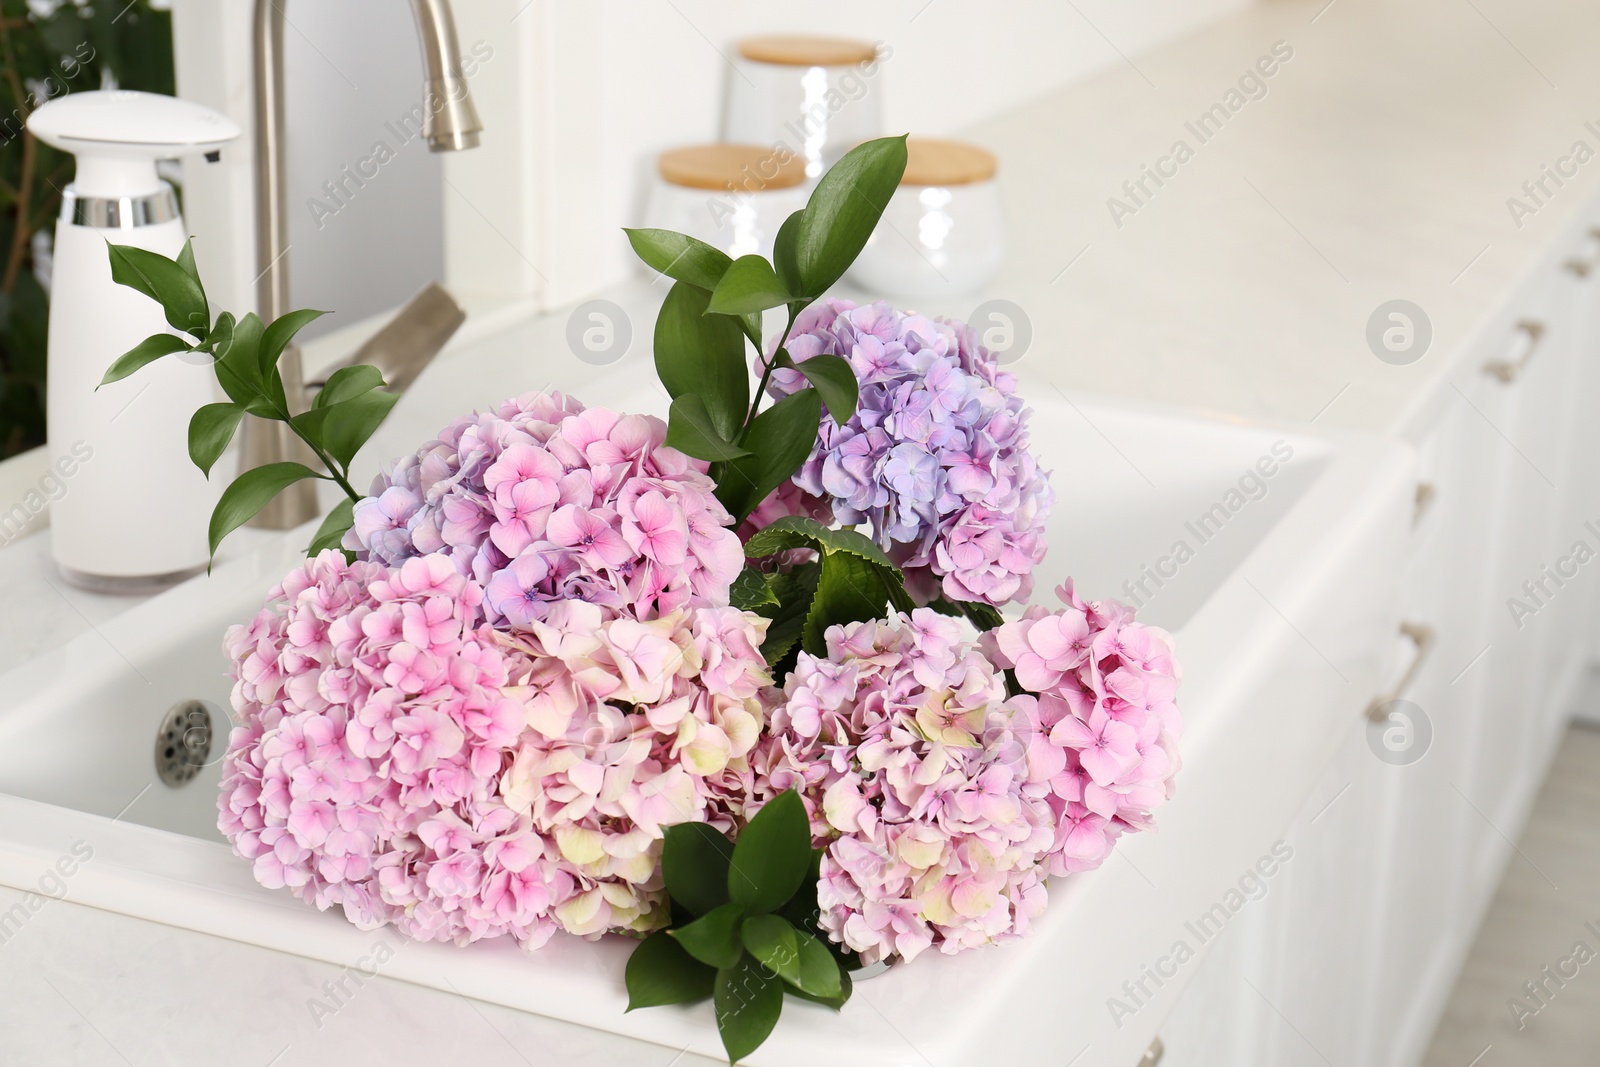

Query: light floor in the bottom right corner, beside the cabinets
[[1424, 726, 1600, 1067]]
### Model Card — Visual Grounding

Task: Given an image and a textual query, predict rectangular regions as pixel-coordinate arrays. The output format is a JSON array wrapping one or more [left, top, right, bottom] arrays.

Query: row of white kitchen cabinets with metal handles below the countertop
[[1162, 202, 1600, 1067]]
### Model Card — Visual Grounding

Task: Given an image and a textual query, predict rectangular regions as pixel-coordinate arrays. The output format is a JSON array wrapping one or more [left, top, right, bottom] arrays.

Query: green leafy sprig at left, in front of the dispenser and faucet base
[[101, 242, 387, 557]]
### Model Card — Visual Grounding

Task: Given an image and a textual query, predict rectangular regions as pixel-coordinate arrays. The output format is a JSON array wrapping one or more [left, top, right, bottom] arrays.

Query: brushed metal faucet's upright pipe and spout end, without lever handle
[[240, 0, 483, 530]]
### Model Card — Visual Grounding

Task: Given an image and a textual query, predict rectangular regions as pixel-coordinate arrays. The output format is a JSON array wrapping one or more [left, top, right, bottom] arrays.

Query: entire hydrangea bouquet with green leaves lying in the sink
[[107, 138, 1181, 1061]]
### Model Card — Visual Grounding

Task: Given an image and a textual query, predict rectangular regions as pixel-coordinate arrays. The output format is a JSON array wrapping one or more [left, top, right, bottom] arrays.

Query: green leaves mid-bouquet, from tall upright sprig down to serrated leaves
[[626, 138, 912, 677]]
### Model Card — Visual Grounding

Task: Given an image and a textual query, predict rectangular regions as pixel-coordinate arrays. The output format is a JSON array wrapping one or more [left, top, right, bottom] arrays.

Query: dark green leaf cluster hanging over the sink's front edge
[[627, 790, 854, 1064]]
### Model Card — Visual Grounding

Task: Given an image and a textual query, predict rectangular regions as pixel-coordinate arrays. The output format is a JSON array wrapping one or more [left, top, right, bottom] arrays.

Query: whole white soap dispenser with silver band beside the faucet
[[27, 90, 240, 593]]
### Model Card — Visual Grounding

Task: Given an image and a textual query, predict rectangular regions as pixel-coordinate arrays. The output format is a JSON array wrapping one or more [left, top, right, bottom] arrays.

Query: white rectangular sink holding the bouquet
[[0, 374, 1411, 1067]]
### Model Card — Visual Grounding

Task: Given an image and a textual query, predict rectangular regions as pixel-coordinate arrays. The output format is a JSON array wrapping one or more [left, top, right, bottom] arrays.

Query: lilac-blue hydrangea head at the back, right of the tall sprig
[[770, 299, 1053, 606]]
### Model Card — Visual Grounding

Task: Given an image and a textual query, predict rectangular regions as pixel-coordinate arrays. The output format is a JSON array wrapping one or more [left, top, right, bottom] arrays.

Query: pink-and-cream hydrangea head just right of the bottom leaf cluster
[[736, 608, 1054, 963]]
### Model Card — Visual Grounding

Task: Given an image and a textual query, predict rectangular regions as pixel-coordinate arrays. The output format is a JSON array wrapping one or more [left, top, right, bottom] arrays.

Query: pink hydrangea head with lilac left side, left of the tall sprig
[[344, 394, 744, 627]]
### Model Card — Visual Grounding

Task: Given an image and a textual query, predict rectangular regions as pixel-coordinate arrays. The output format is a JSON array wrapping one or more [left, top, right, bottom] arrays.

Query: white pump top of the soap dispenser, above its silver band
[[27, 90, 240, 197]]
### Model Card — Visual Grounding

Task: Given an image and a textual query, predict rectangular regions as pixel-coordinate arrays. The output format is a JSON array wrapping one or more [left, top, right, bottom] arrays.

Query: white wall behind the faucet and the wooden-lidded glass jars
[[174, 0, 1251, 322]]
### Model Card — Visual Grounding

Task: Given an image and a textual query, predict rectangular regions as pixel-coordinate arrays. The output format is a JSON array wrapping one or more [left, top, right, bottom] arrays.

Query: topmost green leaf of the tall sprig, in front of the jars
[[779, 136, 906, 296]]
